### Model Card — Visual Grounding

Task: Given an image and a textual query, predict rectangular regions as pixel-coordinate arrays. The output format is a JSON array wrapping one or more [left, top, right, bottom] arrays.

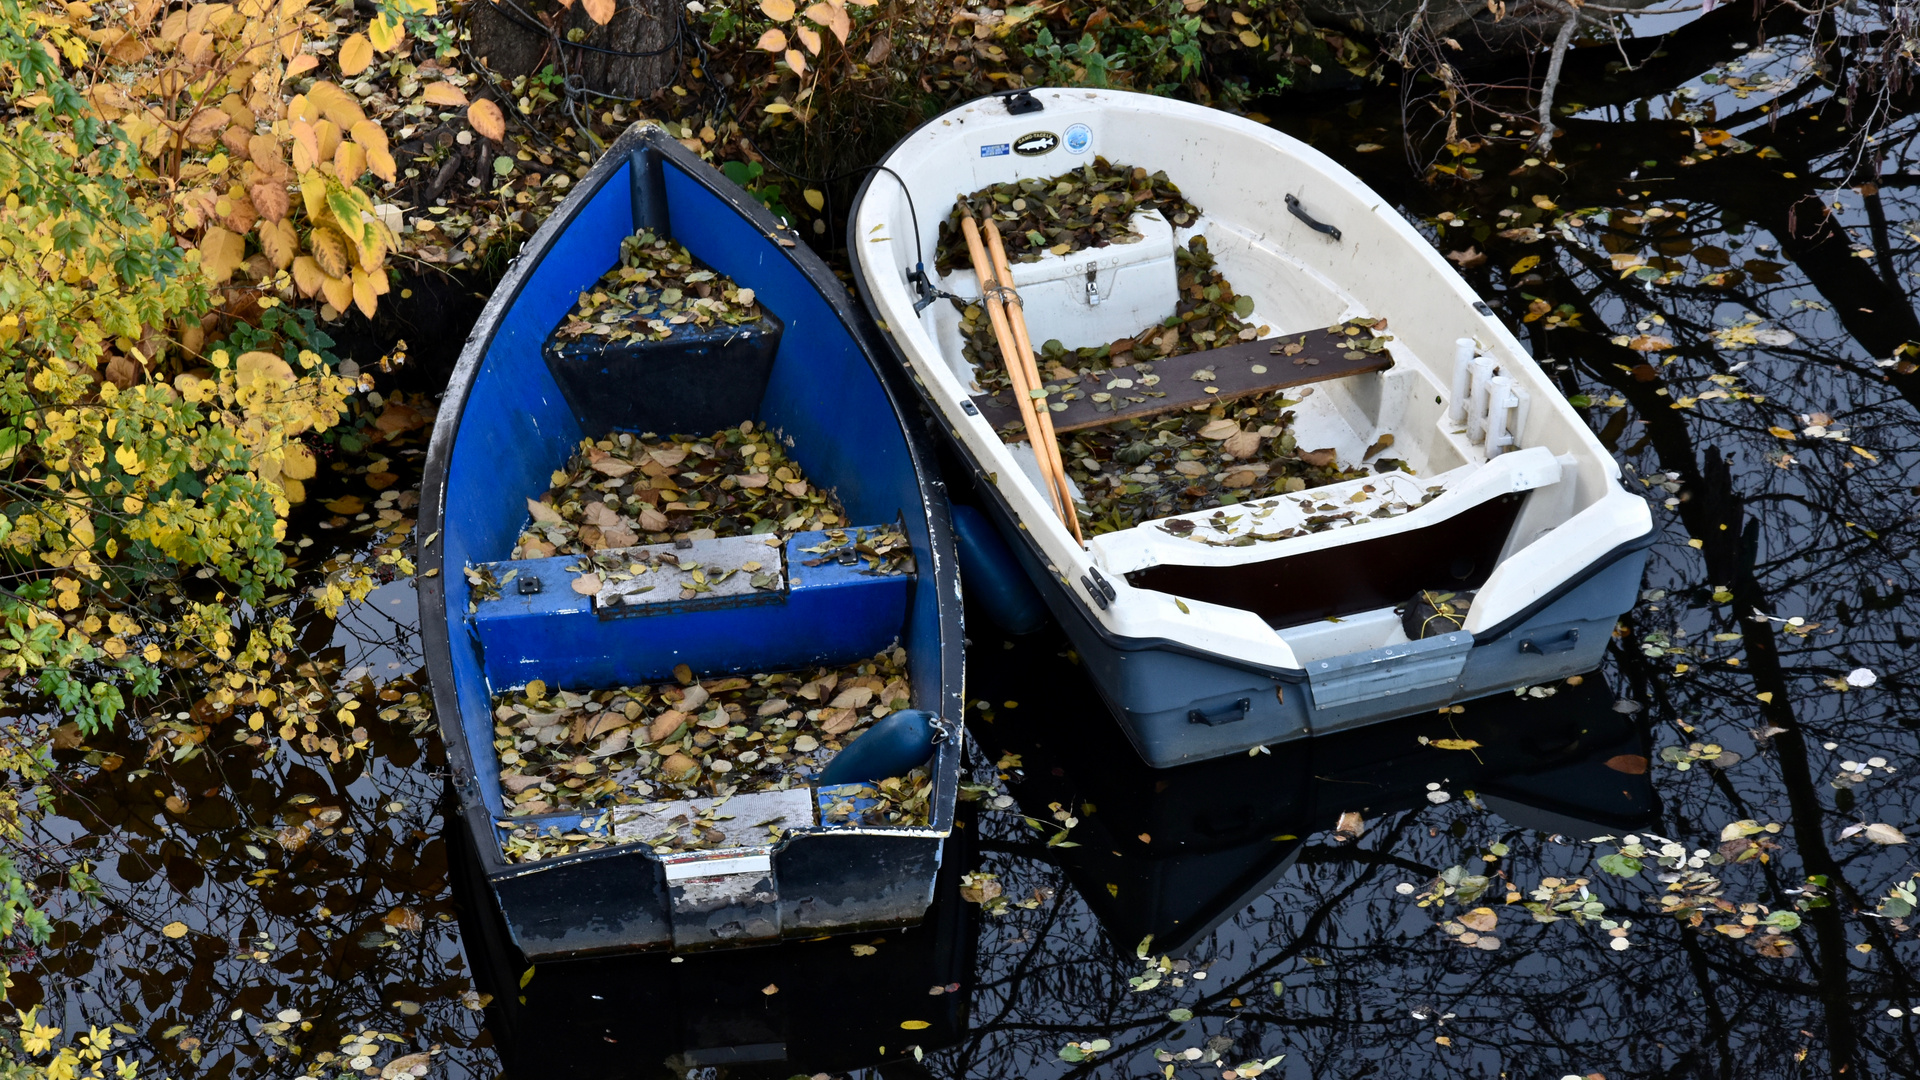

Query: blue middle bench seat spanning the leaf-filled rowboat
[[472, 532, 906, 684]]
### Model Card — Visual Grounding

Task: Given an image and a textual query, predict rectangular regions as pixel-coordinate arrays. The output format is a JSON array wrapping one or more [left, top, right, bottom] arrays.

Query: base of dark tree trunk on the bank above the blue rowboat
[[467, 0, 682, 104]]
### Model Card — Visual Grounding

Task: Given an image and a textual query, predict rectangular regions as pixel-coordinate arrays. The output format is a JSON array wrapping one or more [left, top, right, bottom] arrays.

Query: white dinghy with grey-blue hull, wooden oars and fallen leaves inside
[[849, 88, 1653, 765]]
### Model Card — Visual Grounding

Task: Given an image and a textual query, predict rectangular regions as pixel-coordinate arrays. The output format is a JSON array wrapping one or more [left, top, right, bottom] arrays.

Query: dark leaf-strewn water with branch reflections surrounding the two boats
[[12, 10, 1920, 1080]]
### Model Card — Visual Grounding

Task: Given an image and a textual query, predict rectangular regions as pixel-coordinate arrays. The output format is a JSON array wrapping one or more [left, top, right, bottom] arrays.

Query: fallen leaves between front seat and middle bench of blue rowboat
[[513, 421, 847, 559]]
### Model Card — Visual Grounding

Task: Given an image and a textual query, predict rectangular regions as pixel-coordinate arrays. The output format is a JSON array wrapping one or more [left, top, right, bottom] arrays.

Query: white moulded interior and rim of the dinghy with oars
[[852, 88, 1649, 669]]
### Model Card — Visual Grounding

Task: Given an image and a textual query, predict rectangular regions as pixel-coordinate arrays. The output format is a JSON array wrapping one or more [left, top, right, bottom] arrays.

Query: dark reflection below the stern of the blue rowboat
[[449, 807, 979, 1080]]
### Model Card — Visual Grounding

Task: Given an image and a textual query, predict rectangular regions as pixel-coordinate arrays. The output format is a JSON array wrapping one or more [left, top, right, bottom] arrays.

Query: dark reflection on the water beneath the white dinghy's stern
[[968, 621, 1653, 955]]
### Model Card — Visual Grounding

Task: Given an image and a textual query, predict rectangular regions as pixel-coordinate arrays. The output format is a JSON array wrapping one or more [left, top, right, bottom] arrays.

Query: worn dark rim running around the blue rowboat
[[415, 121, 966, 884]]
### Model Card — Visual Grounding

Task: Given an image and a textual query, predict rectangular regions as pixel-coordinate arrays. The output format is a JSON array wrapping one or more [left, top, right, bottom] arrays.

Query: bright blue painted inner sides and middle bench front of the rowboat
[[430, 148, 945, 817]]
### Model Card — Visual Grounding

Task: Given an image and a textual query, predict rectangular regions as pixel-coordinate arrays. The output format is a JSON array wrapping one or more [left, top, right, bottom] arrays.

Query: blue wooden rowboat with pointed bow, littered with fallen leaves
[[419, 127, 962, 961]]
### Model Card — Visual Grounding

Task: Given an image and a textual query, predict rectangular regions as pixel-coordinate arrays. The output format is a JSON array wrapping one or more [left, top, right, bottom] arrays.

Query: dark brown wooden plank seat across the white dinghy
[[973, 323, 1394, 438]]
